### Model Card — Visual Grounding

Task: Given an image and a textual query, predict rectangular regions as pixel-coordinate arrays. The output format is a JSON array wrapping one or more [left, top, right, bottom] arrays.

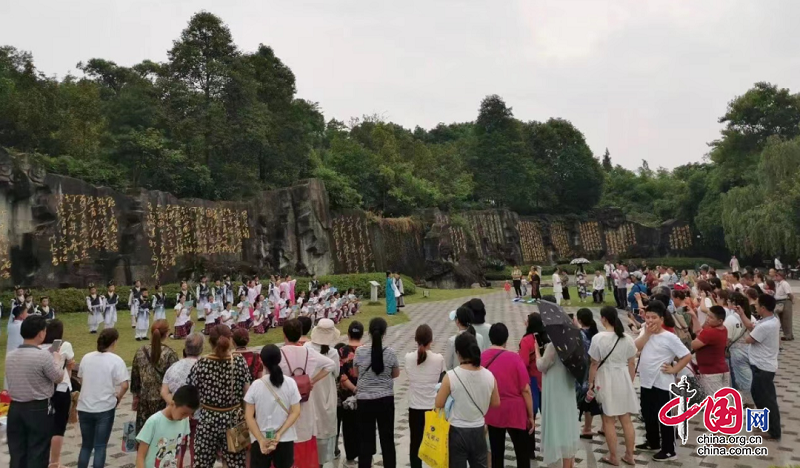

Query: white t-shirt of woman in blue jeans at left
[[78, 351, 129, 413]]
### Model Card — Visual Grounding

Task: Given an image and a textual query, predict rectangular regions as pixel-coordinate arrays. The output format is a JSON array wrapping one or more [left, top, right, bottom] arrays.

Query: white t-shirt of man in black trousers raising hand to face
[[639, 327, 689, 390]]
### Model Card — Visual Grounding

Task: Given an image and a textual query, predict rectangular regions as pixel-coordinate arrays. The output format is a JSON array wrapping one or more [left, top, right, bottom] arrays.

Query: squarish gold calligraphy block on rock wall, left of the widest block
[[50, 194, 119, 266]]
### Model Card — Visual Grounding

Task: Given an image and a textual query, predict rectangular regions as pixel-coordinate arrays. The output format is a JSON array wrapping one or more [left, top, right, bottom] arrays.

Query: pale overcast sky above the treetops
[[0, 0, 800, 169]]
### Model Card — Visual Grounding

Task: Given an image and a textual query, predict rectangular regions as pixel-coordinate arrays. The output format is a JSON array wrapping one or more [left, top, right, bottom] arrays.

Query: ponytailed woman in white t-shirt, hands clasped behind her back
[[244, 345, 300, 468]]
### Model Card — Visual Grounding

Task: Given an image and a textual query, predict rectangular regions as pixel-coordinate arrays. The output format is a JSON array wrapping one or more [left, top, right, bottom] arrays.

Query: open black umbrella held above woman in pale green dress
[[539, 301, 587, 383]]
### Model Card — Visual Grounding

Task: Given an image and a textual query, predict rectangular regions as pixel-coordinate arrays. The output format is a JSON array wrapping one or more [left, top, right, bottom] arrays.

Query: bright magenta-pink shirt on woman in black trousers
[[481, 349, 530, 429]]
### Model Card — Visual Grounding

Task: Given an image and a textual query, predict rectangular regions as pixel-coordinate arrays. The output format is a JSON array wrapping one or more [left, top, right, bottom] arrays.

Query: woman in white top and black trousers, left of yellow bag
[[405, 324, 444, 468]]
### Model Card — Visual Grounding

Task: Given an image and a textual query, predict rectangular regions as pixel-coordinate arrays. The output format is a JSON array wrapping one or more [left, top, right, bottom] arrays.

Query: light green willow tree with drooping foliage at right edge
[[721, 137, 800, 256]]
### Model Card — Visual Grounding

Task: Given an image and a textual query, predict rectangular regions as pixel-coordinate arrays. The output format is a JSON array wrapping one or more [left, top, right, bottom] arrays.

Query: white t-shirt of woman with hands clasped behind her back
[[244, 375, 300, 442]]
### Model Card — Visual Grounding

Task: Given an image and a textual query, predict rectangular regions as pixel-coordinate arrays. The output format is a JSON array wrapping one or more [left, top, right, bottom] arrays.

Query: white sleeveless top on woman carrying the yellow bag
[[447, 367, 497, 428]]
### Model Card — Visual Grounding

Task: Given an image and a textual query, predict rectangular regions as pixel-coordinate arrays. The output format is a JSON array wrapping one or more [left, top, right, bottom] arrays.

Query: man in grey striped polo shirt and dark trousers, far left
[[5, 315, 64, 468]]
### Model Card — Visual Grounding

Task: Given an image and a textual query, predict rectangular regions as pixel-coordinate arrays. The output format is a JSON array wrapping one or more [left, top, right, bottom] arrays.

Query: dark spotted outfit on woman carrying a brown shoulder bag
[[187, 354, 252, 468]]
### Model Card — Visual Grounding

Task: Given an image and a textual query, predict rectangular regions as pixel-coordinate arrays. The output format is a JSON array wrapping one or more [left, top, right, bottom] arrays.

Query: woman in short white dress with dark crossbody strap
[[587, 307, 639, 465]]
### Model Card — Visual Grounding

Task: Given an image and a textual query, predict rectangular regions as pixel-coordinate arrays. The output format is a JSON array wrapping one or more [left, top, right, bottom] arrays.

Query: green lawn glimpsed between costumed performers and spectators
[[0, 288, 490, 381]]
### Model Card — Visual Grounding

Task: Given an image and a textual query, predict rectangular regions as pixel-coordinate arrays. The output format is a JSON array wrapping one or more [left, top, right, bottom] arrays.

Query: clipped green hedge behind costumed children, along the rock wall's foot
[[0, 273, 416, 316]]
